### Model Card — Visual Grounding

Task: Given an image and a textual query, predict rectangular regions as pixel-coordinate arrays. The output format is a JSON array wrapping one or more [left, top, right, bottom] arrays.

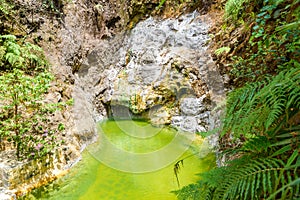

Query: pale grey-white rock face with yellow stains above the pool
[[74, 12, 224, 136]]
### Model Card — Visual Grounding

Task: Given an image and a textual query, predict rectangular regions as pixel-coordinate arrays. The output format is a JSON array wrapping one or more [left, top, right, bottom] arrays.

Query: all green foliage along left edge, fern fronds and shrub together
[[0, 35, 64, 159]]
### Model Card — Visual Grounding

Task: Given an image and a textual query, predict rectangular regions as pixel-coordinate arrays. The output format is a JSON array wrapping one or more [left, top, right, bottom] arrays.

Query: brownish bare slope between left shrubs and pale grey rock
[[29, 0, 209, 148]]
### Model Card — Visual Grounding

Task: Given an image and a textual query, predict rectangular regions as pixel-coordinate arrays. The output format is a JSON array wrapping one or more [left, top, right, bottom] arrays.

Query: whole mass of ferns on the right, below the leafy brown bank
[[174, 46, 300, 200]]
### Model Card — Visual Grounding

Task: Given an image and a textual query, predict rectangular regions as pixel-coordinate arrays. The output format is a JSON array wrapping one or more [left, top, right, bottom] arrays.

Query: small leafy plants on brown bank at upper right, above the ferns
[[231, 0, 300, 85]]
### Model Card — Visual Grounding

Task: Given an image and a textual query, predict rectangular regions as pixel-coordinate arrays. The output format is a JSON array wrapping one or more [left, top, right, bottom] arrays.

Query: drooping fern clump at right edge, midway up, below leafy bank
[[223, 68, 300, 138]]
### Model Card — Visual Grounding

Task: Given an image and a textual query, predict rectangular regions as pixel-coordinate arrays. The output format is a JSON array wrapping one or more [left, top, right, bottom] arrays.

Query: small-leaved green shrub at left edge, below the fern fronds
[[0, 69, 51, 158]]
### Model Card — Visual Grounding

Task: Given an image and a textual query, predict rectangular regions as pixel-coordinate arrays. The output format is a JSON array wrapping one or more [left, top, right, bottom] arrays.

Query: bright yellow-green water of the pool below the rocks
[[26, 121, 215, 200]]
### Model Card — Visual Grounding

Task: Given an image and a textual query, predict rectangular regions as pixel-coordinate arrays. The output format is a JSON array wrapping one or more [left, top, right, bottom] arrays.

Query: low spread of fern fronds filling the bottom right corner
[[174, 144, 300, 200]]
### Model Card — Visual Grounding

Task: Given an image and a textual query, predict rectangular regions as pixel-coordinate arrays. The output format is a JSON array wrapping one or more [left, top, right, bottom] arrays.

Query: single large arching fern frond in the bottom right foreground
[[215, 159, 285, 199]]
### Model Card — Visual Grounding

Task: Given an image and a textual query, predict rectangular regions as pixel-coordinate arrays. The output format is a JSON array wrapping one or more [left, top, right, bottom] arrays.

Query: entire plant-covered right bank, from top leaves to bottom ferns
[[175, 0, 300, 200]]
